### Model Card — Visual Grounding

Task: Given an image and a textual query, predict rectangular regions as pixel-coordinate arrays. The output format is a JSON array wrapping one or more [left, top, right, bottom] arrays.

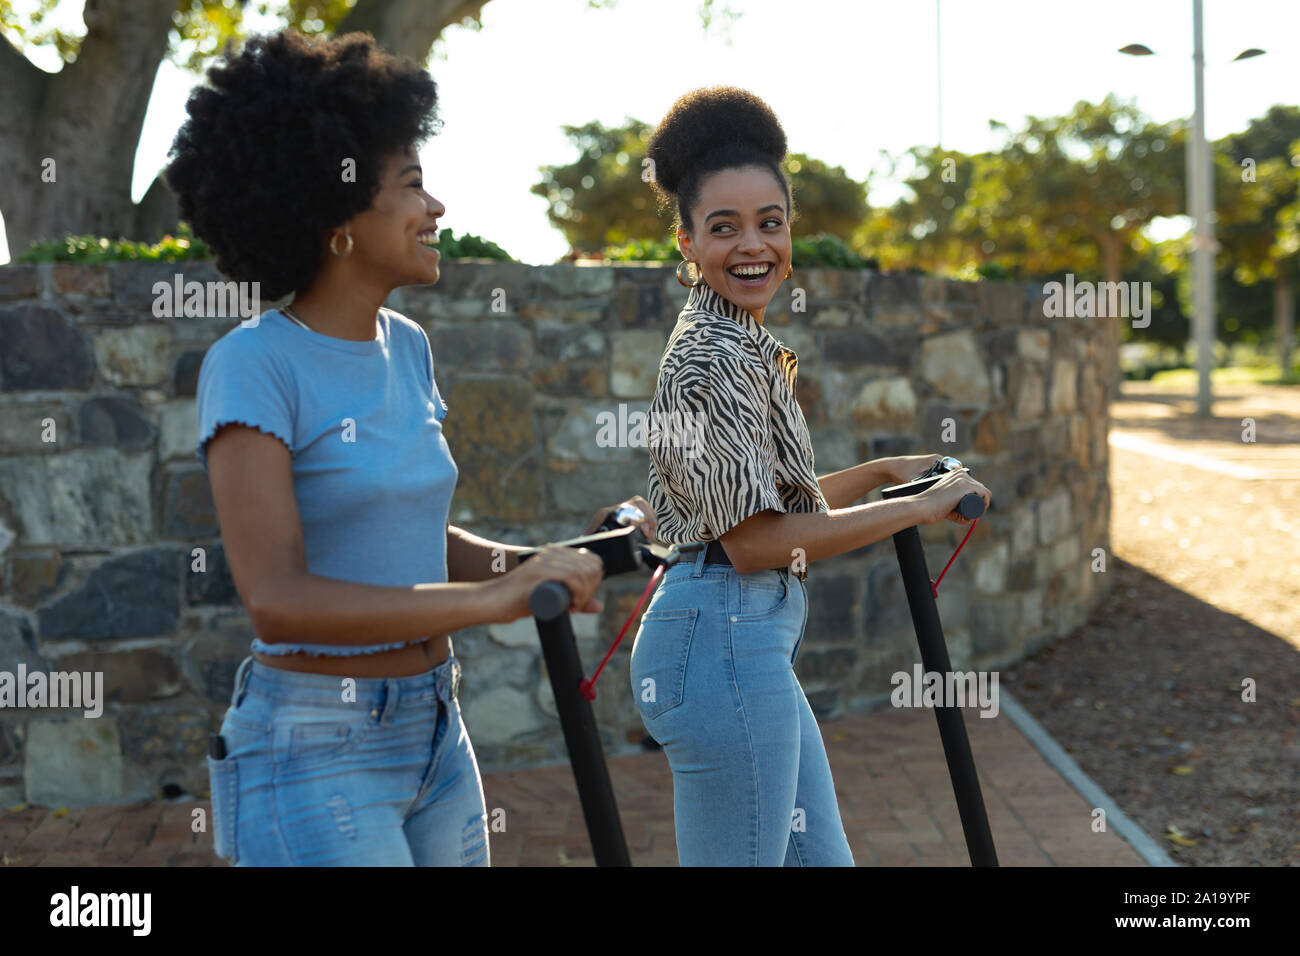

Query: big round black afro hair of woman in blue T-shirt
[[163, 30, 441, 299]]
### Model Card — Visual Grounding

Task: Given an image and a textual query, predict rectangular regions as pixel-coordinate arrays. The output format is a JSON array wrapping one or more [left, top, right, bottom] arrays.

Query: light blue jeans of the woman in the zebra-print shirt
[[631, 550, 854, 866]]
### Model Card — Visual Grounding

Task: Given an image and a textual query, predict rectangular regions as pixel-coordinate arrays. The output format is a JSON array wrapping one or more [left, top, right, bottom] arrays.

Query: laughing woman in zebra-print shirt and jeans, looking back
[[629, 87, 989, 866]]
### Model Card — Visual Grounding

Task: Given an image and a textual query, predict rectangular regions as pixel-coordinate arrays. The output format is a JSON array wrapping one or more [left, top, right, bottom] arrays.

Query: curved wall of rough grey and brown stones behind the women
[[0, 261, 1115, 805]]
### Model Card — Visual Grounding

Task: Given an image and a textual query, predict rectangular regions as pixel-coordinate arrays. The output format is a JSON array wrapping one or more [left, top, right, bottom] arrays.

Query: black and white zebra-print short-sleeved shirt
[[646, 280, 829, 554]]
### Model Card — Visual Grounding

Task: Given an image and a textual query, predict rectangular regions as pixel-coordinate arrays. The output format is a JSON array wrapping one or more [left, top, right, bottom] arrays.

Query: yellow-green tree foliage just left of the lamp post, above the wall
[[854, 98, 1184, 280]]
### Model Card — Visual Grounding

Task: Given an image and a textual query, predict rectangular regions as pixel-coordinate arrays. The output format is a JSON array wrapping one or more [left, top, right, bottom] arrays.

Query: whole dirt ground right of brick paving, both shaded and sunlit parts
[[1006, 382, 1300, 866]]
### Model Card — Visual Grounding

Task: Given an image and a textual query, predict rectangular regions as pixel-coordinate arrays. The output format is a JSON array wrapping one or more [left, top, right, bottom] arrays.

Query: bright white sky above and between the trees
[[0, 0, 1300, 263]]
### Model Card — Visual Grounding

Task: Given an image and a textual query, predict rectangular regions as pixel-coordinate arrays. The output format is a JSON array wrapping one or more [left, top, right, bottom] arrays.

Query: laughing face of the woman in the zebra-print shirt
[[677, 166, 792, 321]]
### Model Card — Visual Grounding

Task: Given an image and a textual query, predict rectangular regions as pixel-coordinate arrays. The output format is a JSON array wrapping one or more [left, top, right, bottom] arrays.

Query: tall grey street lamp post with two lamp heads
[[1119, 0, 1264, 419]]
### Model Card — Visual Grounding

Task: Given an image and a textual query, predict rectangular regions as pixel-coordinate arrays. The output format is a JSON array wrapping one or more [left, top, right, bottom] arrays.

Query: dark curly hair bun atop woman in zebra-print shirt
[[646, 86, 785, 194]]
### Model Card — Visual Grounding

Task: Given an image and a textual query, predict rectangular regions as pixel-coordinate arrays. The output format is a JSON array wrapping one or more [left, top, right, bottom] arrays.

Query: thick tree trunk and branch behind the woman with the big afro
[[0, 0, 488, 258]]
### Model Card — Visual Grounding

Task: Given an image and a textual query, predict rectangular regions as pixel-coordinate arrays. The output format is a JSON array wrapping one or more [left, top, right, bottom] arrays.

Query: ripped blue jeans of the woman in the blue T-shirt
[[208, 654, 490, 866]]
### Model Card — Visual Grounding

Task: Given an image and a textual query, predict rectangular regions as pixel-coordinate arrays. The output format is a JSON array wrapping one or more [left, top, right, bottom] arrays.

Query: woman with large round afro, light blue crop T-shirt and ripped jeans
[[165, 30, 654, 866]]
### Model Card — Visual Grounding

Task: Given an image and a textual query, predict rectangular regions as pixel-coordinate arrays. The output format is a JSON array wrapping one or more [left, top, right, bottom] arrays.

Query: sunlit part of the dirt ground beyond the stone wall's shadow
[[1110, 385, 1300, 649]]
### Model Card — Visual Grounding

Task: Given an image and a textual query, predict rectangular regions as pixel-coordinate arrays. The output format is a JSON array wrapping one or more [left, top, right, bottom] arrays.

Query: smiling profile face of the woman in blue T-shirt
[[350, 147, 447, 289]]
